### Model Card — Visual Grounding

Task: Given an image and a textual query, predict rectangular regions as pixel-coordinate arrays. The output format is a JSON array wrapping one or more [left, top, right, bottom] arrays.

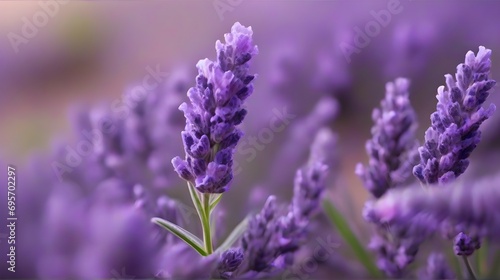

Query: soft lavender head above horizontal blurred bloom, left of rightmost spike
[[356, 78, 418, 198]]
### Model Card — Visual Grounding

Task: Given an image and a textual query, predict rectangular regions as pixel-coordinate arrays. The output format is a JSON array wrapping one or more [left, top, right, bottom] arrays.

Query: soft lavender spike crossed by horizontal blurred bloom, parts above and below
[[356, 78, 419, 277]]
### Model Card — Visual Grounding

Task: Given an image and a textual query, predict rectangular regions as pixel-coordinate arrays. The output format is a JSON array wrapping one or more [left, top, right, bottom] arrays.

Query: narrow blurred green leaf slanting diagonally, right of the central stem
[[323, 199, 382, 278]]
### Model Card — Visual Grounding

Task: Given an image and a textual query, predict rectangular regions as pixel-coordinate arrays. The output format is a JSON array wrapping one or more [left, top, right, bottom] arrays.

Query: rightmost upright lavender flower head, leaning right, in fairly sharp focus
[[413, 46, 496, 184]]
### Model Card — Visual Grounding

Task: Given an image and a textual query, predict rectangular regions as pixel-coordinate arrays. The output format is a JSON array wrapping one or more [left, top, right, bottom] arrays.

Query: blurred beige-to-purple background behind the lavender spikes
[[0, 0, 500, 278]]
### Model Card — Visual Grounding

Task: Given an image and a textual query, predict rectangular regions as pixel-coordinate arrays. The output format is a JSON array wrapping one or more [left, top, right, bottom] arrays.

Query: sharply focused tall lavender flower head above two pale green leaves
[[172, 22, 258, 193]]
